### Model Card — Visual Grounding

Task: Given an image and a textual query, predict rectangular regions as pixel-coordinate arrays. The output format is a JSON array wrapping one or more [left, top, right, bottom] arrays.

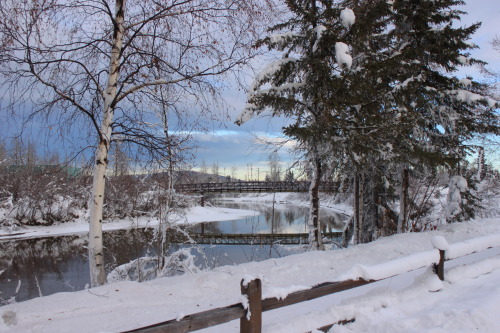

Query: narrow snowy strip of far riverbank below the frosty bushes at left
[[0, 206, 260, 241]]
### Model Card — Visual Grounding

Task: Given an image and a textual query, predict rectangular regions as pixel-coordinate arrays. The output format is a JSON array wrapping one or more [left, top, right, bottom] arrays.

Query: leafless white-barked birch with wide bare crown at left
[[0, 0, 276, 286]]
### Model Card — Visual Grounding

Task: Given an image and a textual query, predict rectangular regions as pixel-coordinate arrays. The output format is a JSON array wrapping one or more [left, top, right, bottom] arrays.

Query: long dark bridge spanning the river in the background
[[174, 181, 340, 193]]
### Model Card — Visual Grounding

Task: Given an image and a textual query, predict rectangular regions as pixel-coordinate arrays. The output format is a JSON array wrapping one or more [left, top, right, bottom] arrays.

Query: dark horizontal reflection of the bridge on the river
[[176, 232, 342, 245]]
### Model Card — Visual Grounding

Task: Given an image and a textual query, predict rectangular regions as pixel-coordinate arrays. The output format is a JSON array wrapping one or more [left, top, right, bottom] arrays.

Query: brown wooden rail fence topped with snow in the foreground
[[127, 234, 500, 333]]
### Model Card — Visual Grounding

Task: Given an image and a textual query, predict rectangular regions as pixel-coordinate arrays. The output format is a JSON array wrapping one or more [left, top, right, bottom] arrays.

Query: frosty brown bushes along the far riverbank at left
[[0, 167, 195, 229]]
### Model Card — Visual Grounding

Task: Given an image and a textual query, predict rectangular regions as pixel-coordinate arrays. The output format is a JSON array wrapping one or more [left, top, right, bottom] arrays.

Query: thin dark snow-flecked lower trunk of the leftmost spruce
[[307, 148, 324, 250]]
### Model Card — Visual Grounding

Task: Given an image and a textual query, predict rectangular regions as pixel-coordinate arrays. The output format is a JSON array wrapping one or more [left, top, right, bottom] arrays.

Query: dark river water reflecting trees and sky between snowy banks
[[0, 203, 345, 305]]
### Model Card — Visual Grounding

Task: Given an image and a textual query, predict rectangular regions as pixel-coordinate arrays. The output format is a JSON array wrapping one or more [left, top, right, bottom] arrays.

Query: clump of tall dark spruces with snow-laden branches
[[237, 0, 498, 241]]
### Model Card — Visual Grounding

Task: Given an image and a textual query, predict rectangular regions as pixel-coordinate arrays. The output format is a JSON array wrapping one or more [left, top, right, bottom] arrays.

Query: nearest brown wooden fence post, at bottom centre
[[240, 279, 262, 333]]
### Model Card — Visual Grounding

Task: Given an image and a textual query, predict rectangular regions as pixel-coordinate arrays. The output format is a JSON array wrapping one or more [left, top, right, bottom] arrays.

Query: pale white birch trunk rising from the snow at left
[[89, 0, 125, 287]]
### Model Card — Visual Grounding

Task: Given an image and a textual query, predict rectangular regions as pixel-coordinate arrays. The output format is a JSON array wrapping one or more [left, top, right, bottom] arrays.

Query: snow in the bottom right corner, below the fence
[[312, 270, 500, 333]]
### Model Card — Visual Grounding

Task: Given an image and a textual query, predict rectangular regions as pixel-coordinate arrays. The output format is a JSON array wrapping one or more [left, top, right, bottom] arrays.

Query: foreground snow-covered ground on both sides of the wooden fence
[[0, 214, 500, 333]]
